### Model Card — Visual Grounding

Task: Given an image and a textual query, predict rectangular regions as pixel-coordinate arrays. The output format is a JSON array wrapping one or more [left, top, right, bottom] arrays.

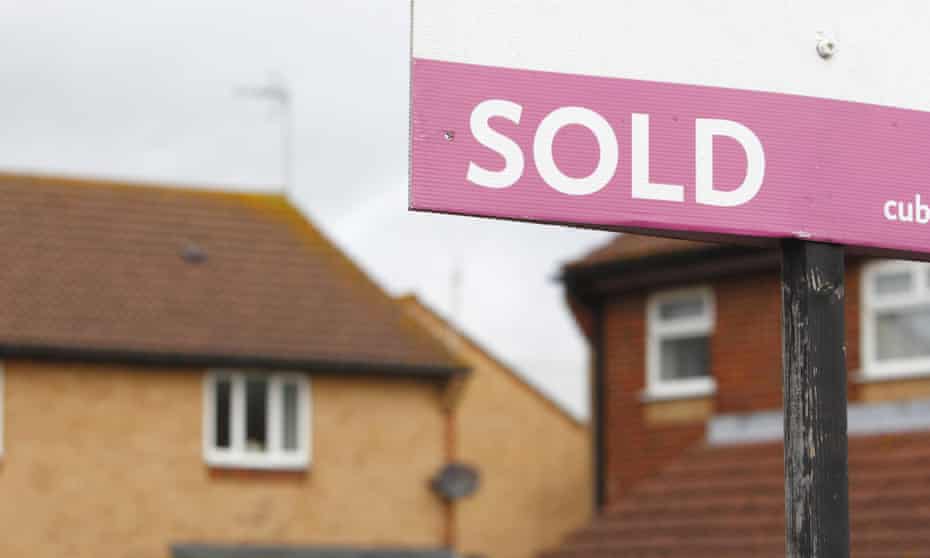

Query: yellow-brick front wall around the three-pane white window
[[0, 361, 444, 558]]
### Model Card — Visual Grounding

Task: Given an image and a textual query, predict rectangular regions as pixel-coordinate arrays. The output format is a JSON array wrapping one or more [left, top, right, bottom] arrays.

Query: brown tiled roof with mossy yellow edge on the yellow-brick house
[[0, 174, 461, 376]]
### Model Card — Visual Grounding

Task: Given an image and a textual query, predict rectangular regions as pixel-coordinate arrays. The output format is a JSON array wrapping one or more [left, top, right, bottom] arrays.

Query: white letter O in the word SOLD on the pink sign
[[533, 107, 620, 196]]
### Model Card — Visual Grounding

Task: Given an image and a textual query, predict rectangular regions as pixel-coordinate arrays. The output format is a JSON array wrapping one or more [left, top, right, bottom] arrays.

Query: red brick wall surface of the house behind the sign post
[[603, 261, 868, 505]]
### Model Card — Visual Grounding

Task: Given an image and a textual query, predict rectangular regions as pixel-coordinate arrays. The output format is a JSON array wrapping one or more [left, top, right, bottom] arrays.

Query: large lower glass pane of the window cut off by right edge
[[875, 306, 930, 360]]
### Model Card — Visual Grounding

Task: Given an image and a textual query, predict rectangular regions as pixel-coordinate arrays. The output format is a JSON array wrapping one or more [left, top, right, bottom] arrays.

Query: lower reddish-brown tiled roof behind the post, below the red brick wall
[[544, 432, 930, 558]]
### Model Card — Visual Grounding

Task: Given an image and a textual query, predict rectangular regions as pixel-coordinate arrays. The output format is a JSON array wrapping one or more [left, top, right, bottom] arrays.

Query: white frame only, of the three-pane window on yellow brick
[[203, 370, 312, 470]]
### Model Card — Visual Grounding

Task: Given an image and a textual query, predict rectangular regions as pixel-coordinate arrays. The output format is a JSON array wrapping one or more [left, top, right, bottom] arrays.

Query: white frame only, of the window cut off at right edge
[[859, 260, 930, 379]]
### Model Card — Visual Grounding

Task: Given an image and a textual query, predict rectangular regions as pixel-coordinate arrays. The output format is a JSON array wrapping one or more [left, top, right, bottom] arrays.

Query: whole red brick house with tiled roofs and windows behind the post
[[547, 235, 930, 558]]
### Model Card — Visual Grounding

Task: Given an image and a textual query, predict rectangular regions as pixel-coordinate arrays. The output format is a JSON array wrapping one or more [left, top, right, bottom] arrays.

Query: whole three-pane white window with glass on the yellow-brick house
[[204, 370, 310, 469]]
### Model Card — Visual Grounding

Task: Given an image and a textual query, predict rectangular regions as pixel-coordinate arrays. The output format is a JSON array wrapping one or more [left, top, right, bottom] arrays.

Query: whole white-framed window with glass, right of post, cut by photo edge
[[862, 261, 930, 377]]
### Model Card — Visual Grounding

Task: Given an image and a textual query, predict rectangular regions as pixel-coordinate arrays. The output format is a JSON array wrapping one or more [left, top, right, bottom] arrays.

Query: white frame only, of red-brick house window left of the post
[[645, 286, 717, 399]]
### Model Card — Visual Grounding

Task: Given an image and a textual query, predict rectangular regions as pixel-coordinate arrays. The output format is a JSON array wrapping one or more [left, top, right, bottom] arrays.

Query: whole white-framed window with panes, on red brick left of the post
[[646, 288, 715, 398]]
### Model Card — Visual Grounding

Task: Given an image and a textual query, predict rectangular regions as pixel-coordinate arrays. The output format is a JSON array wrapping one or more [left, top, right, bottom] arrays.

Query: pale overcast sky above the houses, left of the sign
[[0, 0, 608, 415]]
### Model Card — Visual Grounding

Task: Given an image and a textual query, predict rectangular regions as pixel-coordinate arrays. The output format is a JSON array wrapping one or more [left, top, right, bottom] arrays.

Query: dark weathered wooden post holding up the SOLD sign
[[782, 240, 849, 558]]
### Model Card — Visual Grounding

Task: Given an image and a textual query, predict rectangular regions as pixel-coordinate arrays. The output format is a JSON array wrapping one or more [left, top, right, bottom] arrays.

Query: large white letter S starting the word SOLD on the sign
[[465, 99, 524, 188]]
